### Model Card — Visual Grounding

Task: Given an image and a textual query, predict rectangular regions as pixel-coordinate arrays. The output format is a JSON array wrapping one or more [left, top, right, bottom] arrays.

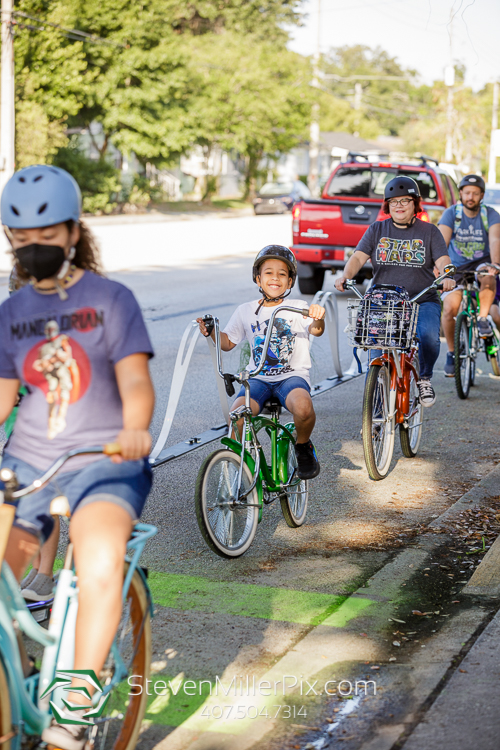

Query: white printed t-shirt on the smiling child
[[224, 299, 312, 384]]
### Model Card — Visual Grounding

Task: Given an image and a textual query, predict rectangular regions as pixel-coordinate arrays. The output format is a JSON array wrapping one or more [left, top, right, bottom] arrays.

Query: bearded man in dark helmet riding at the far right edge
[[438, 174, 500, 378]]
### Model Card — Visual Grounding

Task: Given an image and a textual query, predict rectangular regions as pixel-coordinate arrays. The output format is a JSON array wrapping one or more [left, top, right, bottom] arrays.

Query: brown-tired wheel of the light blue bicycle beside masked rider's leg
[[90, 563, 151, 750]]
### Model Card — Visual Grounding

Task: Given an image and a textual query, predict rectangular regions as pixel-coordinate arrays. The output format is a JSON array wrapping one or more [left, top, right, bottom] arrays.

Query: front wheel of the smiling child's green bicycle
[[195, 450, 259, 557]]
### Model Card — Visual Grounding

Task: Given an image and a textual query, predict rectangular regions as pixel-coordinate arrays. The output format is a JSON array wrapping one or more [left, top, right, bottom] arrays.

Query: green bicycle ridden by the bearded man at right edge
[[455, 264, 500, 399]]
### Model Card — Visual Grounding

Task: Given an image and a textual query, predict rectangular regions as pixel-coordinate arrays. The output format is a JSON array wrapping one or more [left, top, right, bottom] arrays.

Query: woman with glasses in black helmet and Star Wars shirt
[[335, 176, 455, 406]]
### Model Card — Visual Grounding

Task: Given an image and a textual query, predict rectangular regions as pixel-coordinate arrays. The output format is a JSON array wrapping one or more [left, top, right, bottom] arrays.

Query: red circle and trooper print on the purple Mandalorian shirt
[[23, 312, 95, 440]]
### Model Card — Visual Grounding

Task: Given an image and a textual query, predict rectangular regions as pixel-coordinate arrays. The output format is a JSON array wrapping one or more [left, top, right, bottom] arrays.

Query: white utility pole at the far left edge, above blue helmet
[[0, 0, 15, 192]]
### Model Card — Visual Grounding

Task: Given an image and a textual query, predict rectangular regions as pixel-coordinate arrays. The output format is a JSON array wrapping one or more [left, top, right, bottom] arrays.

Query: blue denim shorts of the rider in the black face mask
[[0, 453, 152, 542]]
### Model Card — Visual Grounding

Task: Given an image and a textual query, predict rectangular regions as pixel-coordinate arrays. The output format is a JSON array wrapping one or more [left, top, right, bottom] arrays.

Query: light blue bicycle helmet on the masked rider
[[1, 164, 82, 229]]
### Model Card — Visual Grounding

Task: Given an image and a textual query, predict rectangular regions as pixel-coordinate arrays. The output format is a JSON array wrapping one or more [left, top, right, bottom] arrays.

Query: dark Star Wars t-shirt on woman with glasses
[[356, 219, 448, 303]]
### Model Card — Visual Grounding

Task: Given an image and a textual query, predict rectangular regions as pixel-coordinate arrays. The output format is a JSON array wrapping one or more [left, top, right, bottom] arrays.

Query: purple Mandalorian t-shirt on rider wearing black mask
[[0, 271, 153, 471]]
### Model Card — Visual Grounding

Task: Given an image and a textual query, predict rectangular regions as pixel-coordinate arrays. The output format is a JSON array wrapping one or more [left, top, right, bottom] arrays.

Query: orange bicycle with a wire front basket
[[345, 266, 455, 480]]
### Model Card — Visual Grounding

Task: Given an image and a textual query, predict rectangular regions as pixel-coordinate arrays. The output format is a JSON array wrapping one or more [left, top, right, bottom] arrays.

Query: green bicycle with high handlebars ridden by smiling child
[[195, 306, 309, 558]]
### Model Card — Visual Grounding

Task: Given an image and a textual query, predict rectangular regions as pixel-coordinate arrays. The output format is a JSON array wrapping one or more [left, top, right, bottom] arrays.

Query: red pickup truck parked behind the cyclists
[[291, 154, 459, 294]]
